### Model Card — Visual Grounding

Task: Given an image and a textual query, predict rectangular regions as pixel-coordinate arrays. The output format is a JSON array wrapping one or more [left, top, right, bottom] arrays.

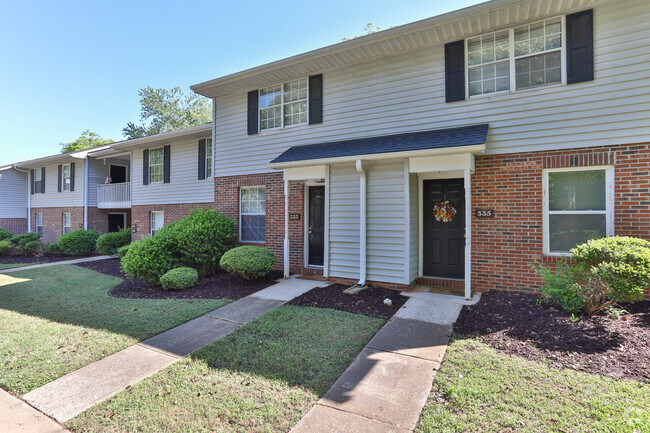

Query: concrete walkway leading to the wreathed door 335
[[291, 292, 478, 433]]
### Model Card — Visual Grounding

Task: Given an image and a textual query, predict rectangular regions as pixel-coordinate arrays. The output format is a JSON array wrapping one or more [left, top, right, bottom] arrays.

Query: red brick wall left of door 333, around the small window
[[214, 173, 305, 273]]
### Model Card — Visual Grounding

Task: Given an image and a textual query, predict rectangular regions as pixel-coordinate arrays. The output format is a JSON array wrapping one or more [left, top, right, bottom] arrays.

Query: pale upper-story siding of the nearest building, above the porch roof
[[215, 0, 650, 176]]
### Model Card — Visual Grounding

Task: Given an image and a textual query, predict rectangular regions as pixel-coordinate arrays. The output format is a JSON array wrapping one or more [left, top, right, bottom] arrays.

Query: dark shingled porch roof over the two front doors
[[269, 123, 488, 168]]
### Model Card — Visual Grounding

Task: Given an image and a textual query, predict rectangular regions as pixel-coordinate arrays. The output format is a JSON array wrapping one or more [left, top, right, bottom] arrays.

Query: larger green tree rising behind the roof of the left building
[[122, 87, 212, 140]]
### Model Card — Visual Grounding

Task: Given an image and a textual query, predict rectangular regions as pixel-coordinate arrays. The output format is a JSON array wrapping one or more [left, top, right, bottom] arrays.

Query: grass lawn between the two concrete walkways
[[67, 305, 384, 433]]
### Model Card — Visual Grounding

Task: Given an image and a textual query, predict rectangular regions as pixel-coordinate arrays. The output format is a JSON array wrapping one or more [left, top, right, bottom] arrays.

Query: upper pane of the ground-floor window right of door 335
[[548, 170, 606, 211]]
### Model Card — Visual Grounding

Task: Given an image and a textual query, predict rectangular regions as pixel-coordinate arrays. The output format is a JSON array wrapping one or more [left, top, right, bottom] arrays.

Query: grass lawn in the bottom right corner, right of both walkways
[[416, 336, 650, 433]]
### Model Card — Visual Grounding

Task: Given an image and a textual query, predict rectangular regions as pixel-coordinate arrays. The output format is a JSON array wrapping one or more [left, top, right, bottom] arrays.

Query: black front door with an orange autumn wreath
[[422, 179, 465, 278]]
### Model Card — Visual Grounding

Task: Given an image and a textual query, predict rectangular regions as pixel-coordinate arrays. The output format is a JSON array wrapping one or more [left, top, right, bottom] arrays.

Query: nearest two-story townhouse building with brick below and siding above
[[192, 0, 650, 297]]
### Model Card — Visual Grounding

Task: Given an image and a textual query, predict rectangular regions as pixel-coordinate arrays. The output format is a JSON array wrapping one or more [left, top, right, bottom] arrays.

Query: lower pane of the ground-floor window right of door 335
[[549, 214, 606, 252]]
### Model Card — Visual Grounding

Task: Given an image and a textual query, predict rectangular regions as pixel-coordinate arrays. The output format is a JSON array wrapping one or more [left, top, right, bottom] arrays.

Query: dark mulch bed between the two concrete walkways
[[289, 284, 408, 318]]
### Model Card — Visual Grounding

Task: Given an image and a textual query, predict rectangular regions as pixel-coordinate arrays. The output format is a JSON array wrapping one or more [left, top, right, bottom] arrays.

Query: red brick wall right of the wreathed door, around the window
[[472, 143, 650, 291]]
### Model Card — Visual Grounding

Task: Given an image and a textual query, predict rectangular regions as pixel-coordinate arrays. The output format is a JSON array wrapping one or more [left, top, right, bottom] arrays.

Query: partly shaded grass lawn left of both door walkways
[[0, 265, 229, 394]]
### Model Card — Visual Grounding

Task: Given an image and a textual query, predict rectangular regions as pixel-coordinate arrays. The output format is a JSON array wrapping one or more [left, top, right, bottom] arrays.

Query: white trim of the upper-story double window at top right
[[464, 15, 567, 99]]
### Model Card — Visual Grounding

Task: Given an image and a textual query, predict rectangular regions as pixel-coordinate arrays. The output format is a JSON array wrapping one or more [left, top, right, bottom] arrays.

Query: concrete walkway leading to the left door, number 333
[[23, 278, 327, 422]]
